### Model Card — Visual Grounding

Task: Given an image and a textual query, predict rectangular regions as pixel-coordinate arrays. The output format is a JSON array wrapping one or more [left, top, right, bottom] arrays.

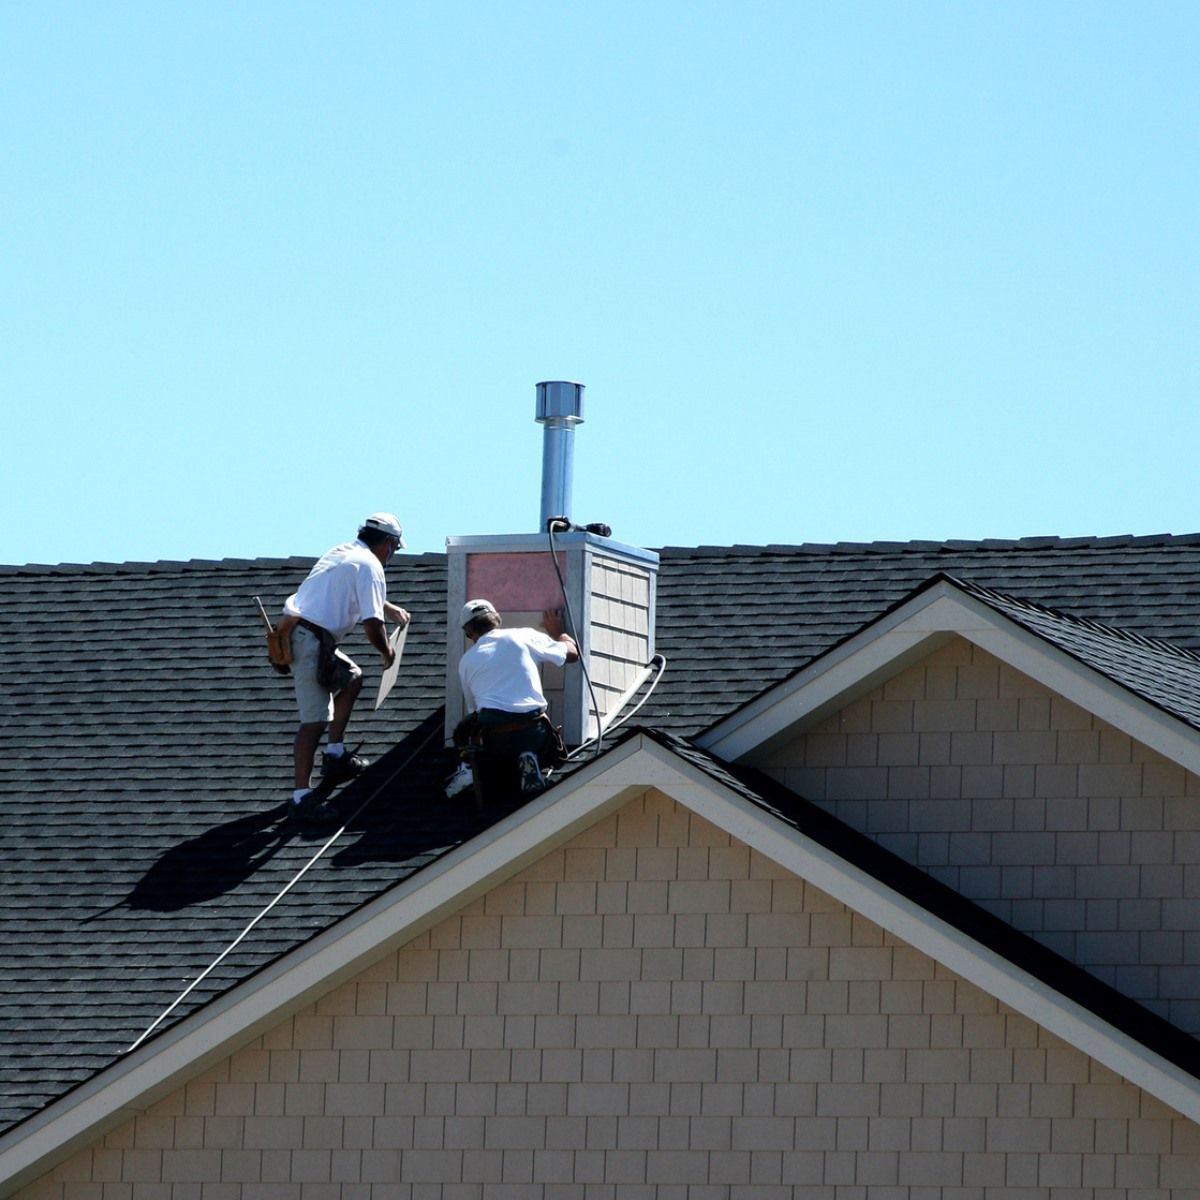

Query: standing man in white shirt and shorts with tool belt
[[280, 512, 409, 822]]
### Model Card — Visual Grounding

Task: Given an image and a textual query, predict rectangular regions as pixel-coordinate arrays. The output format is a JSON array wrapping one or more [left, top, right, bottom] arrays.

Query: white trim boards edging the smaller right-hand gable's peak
[[696, 581, 1200, 773]]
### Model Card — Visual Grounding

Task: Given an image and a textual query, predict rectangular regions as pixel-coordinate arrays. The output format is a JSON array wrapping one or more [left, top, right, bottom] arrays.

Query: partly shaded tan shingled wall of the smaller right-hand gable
[[754, 638, 1200, 1034]]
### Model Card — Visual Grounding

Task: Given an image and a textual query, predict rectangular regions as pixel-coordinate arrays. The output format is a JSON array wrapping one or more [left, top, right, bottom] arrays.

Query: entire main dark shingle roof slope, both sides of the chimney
[[7, 536, 1200, 1128]]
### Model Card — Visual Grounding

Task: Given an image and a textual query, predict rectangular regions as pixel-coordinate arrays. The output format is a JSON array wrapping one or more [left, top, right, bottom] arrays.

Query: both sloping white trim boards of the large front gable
[[0, 736, 1200, 1195]]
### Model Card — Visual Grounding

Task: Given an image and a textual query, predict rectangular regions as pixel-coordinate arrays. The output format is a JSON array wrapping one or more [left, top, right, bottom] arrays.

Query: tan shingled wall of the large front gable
[[20, 792, 1200, 1200]]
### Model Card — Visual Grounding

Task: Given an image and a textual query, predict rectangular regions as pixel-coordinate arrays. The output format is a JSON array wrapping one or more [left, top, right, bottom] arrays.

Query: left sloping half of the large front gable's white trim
[[0, 738, 670, 1196]]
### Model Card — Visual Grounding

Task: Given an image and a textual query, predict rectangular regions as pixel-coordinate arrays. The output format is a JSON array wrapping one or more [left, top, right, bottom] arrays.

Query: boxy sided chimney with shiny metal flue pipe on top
[[445, 382, 659, 745]]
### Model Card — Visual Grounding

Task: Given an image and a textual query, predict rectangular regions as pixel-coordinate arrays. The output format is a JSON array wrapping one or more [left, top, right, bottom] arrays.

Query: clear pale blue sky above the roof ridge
[[0, 0, 1200, 563]]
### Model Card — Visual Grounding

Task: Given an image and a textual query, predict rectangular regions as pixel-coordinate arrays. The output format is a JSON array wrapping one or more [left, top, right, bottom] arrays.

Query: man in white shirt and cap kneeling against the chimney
[[458, 600, 580, 796]]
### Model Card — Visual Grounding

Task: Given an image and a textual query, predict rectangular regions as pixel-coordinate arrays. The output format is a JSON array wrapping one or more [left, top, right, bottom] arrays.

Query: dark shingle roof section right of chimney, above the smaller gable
[[640, 535, 1200, 737]]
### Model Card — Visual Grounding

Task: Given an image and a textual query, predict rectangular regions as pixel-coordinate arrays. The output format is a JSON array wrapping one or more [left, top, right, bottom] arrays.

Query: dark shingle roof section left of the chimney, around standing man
[[0, 556, 458, 1124]]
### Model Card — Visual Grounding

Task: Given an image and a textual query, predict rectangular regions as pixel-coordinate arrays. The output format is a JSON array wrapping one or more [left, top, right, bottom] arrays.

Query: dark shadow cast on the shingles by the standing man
[[83, 804, 301, 923]]
